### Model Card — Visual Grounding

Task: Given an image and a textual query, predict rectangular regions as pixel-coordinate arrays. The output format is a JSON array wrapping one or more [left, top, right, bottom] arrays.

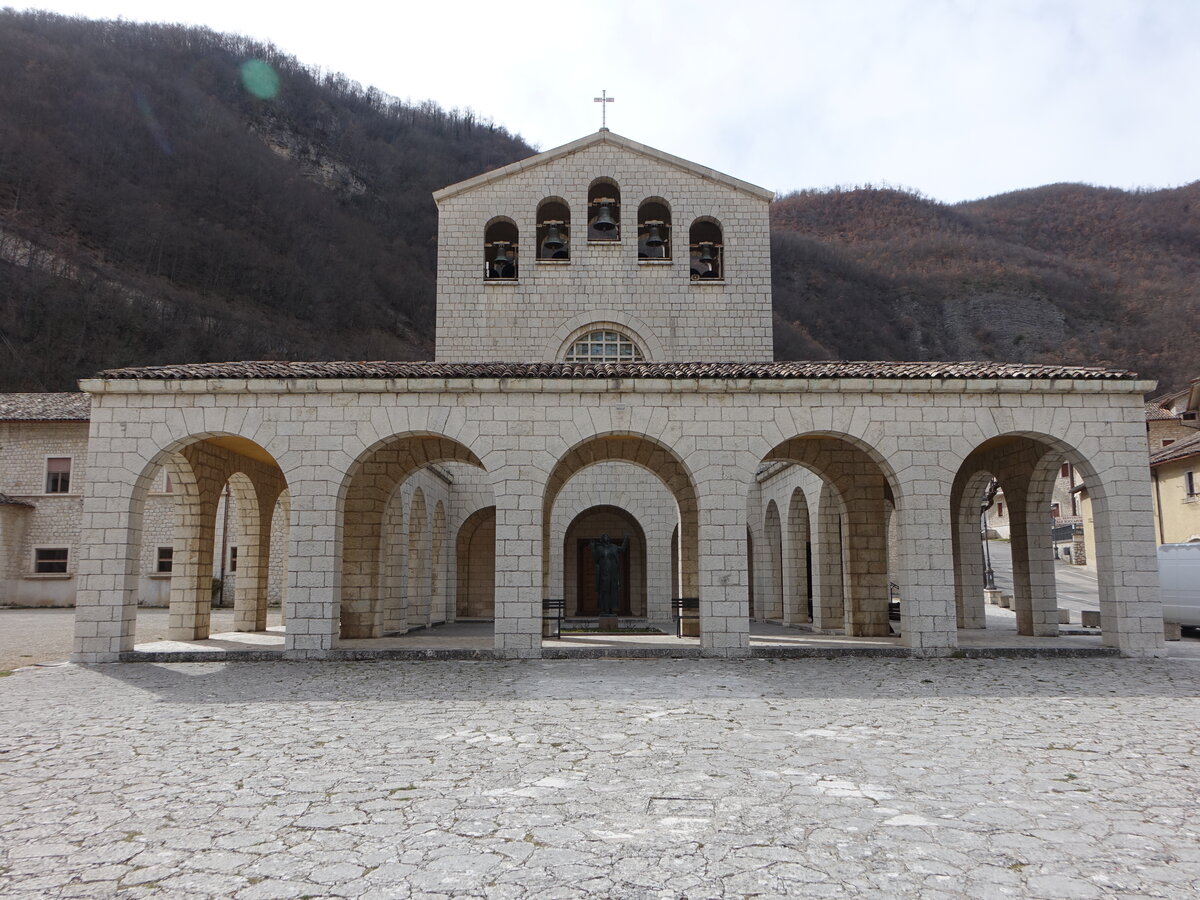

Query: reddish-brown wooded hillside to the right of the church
[[772, 182, 1200, 388]]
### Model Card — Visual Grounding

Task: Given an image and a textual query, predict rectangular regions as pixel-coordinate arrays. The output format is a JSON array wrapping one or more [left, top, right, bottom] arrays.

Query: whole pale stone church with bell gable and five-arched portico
[[74, 131, 1163, 661]]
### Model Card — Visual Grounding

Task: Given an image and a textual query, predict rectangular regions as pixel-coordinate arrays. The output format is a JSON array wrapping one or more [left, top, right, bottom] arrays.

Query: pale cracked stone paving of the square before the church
[[0, 659, 1200, 900]]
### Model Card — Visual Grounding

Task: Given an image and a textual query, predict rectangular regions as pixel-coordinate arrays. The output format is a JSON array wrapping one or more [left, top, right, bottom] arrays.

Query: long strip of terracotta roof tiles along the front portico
[[97, 360, 1136, 380]]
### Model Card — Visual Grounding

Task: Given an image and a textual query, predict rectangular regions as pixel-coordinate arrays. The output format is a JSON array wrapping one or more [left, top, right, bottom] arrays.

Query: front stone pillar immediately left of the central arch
[[488, 475, 546, 659]]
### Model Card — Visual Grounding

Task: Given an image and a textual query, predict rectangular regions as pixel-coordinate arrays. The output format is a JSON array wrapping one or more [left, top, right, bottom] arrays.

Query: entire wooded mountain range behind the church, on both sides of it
[[0, 11, 1200, 390]]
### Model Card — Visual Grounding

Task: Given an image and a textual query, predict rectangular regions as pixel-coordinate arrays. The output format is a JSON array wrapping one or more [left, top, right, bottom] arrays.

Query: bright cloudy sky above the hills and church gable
[[18, 0, 1200, 202]]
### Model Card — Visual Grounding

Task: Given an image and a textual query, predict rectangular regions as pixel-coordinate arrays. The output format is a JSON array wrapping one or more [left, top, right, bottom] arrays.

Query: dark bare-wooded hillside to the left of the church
[[0, 11, 533, 390]]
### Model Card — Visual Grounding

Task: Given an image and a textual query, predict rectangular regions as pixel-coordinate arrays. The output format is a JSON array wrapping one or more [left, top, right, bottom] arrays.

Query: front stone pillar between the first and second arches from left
[[283, 466, 344, 659]]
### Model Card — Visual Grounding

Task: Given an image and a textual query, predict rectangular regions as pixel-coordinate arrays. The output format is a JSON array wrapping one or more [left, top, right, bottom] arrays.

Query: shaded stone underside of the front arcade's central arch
[[541, 432, 700, 609]]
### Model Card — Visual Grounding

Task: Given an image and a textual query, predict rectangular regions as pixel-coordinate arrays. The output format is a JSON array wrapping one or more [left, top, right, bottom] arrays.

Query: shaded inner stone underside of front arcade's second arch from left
[[337, 432, 486, 638]]
